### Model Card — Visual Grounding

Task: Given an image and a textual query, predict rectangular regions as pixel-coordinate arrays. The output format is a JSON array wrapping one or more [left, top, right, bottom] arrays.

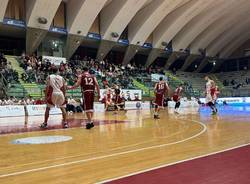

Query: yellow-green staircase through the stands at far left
[[6, 56, 42, 98]]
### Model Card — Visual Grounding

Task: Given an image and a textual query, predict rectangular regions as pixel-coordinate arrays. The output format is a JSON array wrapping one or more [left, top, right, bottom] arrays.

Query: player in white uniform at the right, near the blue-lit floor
[[205, 76, 217, 115]]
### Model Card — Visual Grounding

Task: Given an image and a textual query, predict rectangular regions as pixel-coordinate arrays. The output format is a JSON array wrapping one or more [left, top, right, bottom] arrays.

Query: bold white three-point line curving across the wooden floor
[[0, 120, 207, 178]]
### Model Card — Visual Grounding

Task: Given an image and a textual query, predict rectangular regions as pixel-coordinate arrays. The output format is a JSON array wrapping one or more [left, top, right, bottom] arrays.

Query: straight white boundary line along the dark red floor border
[[96, 143, 250, 184]]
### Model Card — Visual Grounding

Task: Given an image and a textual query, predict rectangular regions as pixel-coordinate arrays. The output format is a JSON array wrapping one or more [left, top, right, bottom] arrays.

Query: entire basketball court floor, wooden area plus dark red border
[[0, 106, 250, 184]]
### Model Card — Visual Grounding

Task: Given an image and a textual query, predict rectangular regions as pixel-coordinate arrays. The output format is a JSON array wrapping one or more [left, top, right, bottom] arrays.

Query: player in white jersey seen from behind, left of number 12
[[40, 68, 68, 128]]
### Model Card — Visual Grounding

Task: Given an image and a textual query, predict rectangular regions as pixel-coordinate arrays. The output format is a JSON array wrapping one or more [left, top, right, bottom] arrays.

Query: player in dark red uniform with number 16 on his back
[[154, 77, 169, 119]]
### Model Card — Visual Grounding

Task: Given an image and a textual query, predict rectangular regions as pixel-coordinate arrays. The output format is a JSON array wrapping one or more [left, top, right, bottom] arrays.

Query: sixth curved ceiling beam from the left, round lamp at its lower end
[[153, 0, 216, 48]]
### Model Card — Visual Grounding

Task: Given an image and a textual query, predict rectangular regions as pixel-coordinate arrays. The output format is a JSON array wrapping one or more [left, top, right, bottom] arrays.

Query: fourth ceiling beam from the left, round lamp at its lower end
[[100, 0, 148, 41]]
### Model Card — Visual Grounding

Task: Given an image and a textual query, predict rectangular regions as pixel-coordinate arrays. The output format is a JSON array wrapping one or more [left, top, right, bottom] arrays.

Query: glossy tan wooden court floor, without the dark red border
[[0, 107, 250, 184]]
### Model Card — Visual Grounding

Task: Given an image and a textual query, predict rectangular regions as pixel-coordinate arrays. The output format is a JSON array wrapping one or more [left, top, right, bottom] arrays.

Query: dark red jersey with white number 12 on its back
[[81, 72, 96, 92]]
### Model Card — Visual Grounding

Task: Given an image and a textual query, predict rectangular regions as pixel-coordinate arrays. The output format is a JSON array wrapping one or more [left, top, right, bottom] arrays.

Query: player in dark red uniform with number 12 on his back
[[68, 67, 100, 129]]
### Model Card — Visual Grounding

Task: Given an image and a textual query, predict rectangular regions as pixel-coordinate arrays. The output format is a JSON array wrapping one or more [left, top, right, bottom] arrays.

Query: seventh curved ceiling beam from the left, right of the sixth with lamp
[[172, 0, 239, 50]]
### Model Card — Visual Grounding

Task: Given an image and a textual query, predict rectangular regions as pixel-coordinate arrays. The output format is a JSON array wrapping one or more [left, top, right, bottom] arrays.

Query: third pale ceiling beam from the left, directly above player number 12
[[67, 0, 107, 36]]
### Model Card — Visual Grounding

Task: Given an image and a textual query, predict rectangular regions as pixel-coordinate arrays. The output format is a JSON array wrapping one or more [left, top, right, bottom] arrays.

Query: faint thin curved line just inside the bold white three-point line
[[0, 120, 190, 171]]
